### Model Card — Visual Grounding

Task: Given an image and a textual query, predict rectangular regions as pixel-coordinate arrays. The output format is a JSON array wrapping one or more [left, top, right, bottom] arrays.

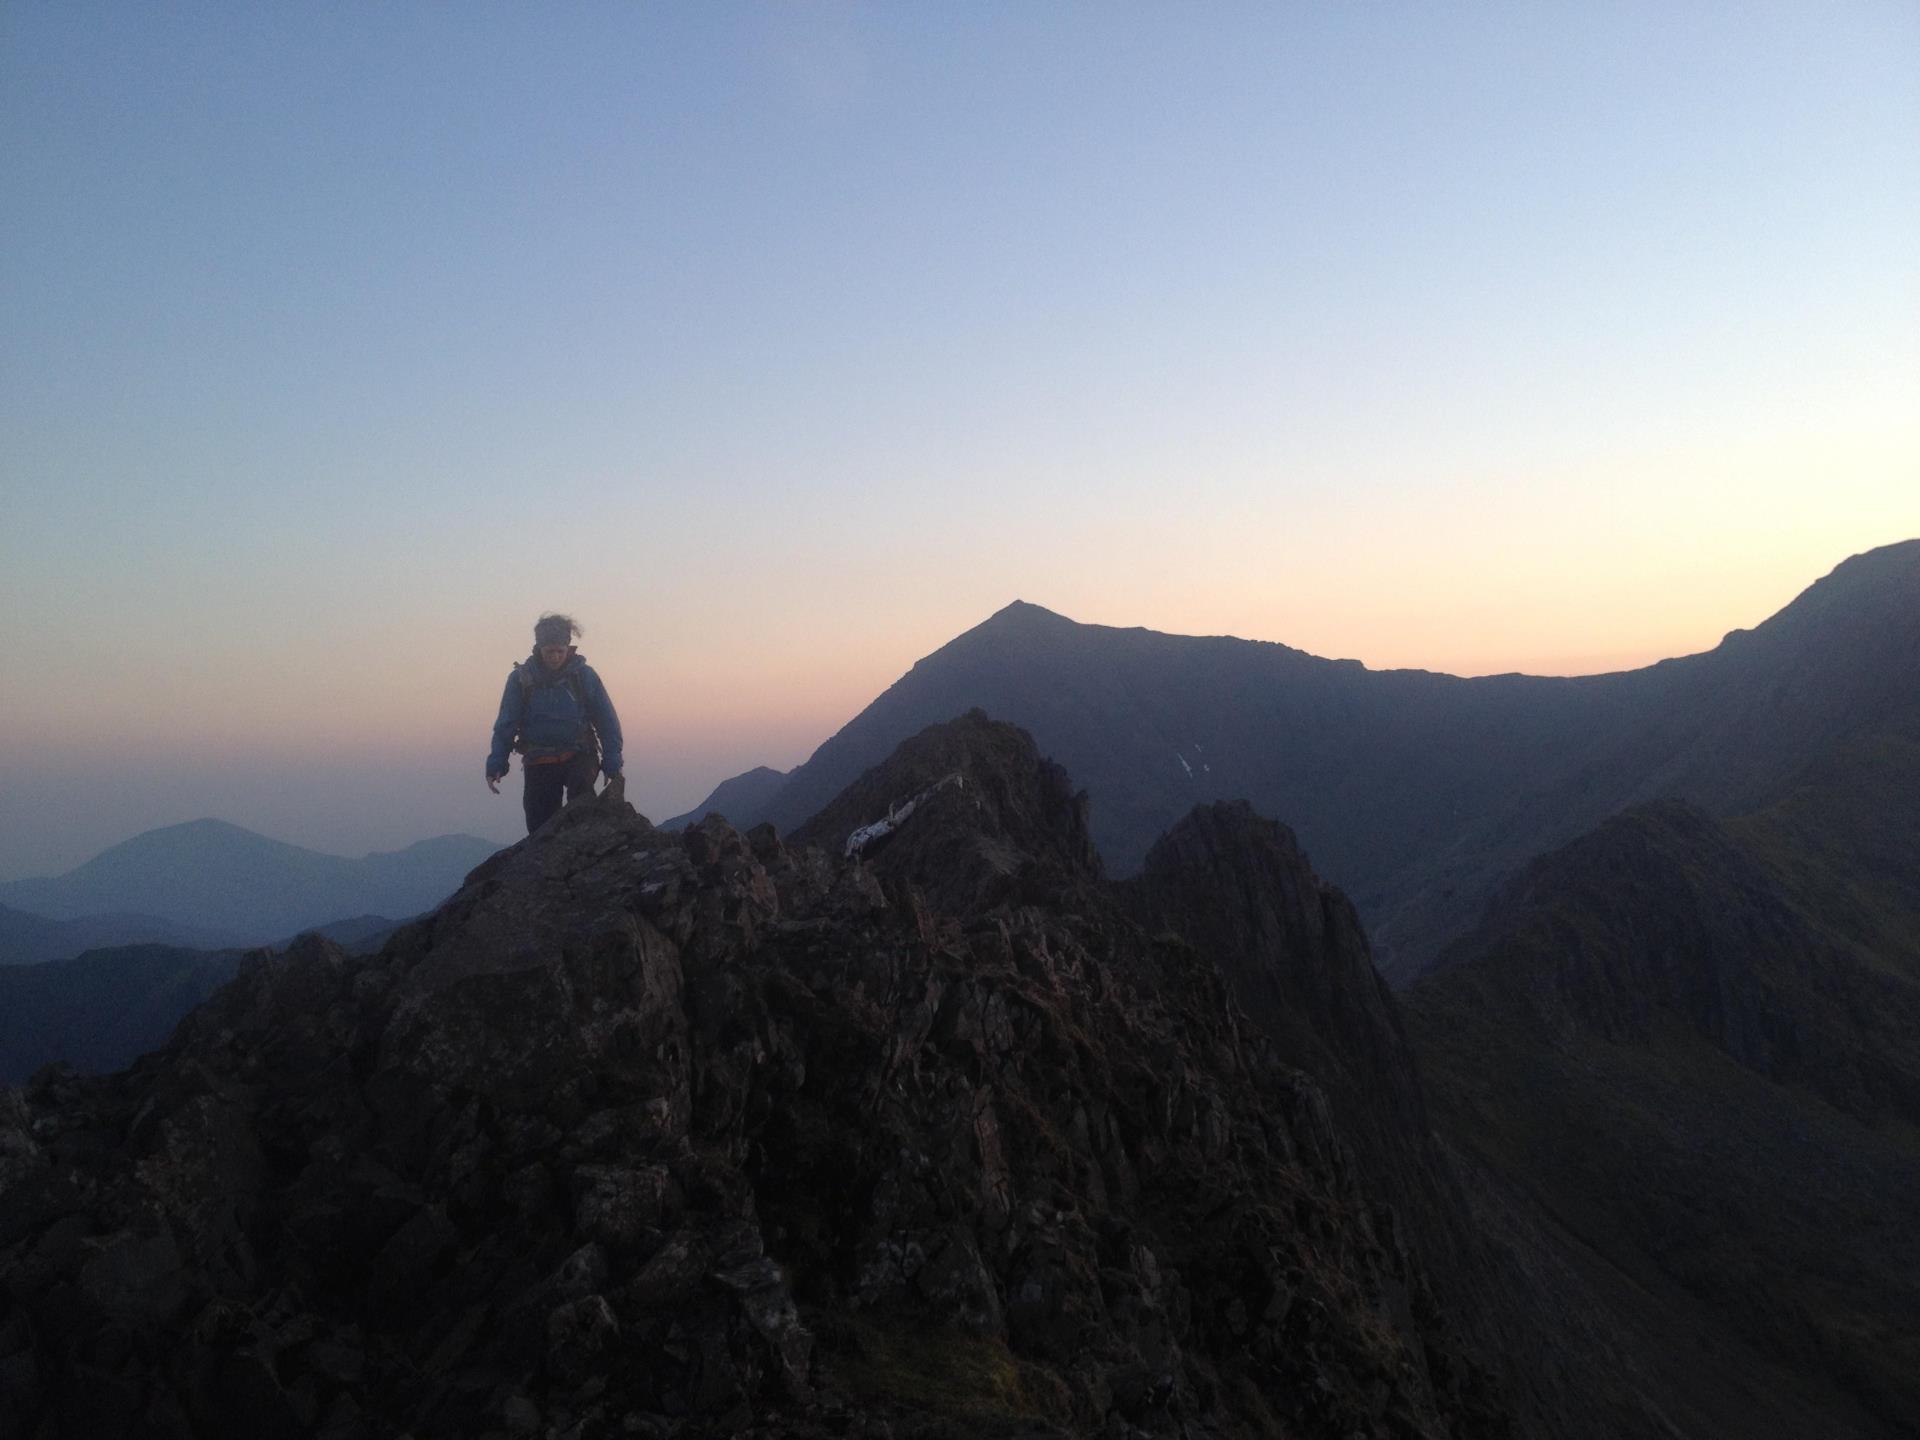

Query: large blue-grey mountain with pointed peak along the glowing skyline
[[695, 541, 1920, 979]]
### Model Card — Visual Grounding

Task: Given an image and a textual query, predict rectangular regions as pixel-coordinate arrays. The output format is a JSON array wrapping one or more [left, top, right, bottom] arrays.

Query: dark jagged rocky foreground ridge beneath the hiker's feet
[[0, 714, 1519, 1440]]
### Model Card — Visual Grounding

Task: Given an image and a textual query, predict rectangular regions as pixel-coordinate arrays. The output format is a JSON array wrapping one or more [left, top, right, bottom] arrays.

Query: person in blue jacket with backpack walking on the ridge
[[486, 614, 620, 835]]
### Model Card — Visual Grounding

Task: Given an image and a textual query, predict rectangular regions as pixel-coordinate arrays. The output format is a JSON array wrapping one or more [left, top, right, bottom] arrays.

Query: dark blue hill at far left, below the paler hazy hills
[[0, 945, 240, 1085]]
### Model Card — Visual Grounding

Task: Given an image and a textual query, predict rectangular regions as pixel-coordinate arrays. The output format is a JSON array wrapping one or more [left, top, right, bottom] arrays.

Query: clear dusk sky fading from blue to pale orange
[[0, 0, 1920, 879]]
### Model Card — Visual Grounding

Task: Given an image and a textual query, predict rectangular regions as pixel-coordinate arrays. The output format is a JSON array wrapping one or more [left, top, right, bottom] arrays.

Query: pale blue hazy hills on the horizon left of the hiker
[[0, 820, 499, 945]]
